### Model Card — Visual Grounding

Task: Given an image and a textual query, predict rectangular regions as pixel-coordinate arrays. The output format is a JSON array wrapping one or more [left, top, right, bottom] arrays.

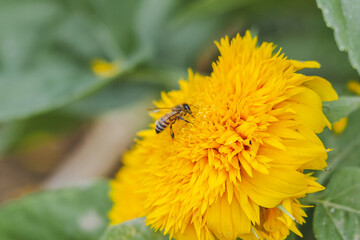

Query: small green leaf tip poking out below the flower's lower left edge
[[100, 218, 169, 240]]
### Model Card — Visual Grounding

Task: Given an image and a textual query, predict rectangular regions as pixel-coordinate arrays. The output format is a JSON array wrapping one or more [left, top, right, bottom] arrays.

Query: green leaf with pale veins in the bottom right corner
[[313, 168, 360, 240]]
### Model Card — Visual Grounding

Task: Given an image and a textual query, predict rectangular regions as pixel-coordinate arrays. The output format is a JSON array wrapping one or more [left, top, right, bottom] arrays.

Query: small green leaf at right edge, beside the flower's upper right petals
[[324, 96, 360, 123]]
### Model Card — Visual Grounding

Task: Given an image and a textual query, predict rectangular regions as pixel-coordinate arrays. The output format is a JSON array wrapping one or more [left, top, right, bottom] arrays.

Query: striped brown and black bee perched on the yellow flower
[[150, 103, 193, 139]]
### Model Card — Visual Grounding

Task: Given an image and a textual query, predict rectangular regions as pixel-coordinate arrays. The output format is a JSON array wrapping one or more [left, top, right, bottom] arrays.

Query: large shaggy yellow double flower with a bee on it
[[110, 32, 337, 240]]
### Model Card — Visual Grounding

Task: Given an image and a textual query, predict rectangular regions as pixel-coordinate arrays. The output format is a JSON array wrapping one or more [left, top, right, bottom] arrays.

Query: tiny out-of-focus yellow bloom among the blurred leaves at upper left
[[91, 59, 120, 78]]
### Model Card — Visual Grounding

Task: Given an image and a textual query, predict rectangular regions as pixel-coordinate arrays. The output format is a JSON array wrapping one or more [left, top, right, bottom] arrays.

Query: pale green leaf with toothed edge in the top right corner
[[316, 0, 360, 73]]
